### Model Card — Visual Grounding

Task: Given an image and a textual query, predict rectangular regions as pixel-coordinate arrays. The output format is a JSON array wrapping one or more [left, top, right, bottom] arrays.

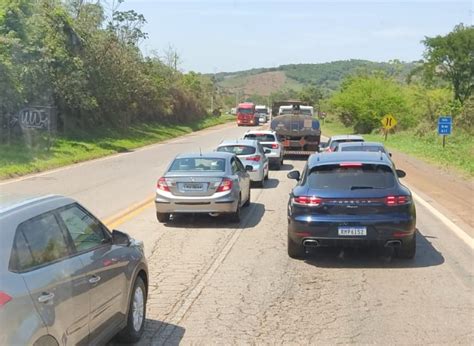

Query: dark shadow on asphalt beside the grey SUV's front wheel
[[111, 318, 185, 346]]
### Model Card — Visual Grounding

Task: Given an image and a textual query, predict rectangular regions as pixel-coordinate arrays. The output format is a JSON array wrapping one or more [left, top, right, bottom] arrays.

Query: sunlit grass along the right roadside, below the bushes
[[321, 119, 474, 177]]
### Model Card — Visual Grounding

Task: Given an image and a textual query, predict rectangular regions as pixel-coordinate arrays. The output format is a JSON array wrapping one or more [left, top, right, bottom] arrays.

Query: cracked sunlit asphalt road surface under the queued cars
[[0, 121, 474, 345]]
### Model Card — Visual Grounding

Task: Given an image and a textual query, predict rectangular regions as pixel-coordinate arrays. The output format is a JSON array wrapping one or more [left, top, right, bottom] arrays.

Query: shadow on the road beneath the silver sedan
[[164, 203, 265, 230]]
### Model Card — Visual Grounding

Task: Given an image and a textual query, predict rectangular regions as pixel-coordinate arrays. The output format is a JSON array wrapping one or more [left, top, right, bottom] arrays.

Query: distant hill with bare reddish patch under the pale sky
[[214, 60, 416, 96]]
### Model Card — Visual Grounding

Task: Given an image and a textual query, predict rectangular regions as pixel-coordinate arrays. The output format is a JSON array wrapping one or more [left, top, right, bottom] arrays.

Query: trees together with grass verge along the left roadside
[[0, 0, 229, 178]]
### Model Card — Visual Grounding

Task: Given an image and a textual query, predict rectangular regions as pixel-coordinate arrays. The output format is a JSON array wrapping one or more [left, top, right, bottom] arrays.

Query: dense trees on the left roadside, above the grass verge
[[0, 0, 214, 139]]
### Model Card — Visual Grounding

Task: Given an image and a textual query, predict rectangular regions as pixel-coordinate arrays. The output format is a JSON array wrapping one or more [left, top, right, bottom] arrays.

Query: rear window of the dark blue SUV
[[306, 164, 395, 190]]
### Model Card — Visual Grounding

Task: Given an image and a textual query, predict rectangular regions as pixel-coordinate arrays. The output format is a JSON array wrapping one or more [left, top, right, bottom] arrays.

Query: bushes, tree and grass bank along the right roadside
[[321, 25, 474, 176]]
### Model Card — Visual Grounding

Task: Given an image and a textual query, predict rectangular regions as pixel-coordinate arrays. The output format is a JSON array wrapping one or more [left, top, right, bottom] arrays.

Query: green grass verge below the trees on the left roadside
[[0, 115, 235, 179]]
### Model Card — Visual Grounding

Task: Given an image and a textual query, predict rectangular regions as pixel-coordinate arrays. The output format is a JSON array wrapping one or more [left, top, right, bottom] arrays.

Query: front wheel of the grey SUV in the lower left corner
[[117, 277, 147, 343]]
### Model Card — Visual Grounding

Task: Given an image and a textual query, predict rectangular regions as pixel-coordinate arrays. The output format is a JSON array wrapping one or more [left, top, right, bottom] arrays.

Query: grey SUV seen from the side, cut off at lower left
[[0, 195, 148, 346]]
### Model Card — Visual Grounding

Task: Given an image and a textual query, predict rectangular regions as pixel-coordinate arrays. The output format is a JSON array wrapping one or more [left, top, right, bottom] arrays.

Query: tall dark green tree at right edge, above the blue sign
[[423, 24, 474, 103]]
